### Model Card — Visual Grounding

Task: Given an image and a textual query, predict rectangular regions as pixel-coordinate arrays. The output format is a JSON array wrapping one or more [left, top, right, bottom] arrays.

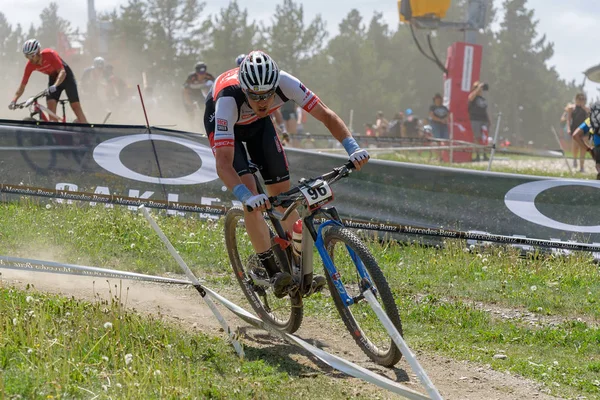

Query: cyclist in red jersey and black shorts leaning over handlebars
[[8, 39, 88, 124]]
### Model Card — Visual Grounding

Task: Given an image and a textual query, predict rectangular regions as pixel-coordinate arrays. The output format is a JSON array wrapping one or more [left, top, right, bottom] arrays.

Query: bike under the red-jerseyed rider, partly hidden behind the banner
[[15, 90, 88, 174]]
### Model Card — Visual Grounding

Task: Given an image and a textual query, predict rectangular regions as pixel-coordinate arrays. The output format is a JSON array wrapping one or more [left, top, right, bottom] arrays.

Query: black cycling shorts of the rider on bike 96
[[204, 115, 290, 185]]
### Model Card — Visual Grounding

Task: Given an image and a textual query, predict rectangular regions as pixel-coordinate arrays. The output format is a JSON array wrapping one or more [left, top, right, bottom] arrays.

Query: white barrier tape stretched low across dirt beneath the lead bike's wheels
[[204, 287, 432, 400]]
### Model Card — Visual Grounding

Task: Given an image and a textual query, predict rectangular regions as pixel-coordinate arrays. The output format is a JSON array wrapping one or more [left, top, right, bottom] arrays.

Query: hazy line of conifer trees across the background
[[16, 0, 578, 144]]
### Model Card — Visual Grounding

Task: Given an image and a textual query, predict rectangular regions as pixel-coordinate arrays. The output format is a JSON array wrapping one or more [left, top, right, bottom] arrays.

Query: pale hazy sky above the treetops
[[0, 0, 600, 96]]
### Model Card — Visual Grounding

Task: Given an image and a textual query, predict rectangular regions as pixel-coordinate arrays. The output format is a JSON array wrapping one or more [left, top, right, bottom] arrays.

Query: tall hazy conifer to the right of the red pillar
[[490, 0, 570, 143]]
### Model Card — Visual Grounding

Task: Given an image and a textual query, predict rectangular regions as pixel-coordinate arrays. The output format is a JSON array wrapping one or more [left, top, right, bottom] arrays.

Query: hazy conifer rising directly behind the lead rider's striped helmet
[[202, 0, 261, 75]]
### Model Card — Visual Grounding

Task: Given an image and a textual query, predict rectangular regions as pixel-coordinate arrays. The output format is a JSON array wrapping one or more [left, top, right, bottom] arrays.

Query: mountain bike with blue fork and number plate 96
[[225, 163, 402, 367]]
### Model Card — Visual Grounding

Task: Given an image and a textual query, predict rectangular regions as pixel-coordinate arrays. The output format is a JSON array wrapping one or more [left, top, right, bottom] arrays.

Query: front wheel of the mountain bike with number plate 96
[[323, 225, 402, 367]]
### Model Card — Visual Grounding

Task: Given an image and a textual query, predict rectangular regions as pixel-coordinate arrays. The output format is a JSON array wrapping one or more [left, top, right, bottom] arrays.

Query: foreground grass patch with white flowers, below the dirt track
[[0, 287, 366, 399]]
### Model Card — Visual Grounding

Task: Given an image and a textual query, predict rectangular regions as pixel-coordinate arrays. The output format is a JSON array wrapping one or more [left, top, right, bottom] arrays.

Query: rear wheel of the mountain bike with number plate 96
[[225, 208, 303, 333]]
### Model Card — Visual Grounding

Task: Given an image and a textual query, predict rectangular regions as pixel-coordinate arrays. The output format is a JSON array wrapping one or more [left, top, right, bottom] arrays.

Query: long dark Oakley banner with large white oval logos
[[0, 120, 600, 243]]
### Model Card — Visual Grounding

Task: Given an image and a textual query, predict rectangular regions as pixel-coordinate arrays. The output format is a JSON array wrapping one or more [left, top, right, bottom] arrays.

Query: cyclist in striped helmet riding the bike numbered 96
[[204, 51, 369, 297]]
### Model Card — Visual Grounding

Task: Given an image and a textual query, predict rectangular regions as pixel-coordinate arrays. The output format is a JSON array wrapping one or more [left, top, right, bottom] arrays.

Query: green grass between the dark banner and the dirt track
[[0, 203, 600, 398]]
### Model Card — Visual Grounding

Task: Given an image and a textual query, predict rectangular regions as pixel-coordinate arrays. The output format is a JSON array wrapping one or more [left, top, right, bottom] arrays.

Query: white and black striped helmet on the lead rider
[[239, 50, 279, 92]]
